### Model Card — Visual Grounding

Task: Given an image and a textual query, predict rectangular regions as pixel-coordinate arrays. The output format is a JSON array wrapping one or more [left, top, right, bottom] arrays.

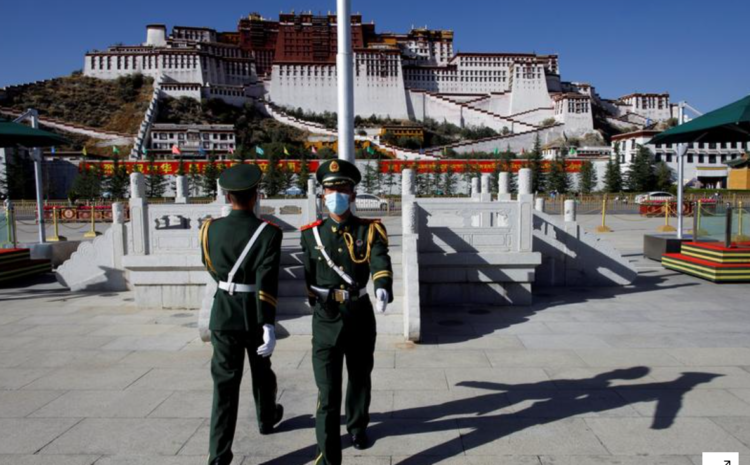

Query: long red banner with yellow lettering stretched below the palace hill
[[79, 160, 583, 176]]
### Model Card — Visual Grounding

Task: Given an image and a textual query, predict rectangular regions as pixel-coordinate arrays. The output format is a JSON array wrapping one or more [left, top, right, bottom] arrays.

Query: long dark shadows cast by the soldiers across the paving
[[264, 366, 723, 465]]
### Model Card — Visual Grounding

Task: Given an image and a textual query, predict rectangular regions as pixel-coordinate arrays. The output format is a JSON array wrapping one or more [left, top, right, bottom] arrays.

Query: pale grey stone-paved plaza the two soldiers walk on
[[0, 216, 750, 465]]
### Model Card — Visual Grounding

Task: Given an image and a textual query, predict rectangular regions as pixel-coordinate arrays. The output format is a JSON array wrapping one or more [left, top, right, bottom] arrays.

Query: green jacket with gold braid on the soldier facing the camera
[[302, 215, 393, 302]]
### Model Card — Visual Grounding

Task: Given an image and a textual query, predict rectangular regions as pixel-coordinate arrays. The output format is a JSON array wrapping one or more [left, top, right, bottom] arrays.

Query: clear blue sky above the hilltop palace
[[0, 0, 750, 111]]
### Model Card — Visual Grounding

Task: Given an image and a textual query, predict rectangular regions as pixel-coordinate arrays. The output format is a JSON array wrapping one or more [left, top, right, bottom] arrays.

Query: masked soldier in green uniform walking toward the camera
[[302, 160, 393, 465]]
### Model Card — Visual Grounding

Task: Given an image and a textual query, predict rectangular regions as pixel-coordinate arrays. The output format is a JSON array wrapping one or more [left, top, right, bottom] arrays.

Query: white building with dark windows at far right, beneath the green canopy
[[612, 130, 750, 189]]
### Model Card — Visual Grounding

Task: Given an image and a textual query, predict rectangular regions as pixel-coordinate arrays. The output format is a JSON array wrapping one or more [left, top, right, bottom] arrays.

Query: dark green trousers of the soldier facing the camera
[[312, 298, 376, 465]]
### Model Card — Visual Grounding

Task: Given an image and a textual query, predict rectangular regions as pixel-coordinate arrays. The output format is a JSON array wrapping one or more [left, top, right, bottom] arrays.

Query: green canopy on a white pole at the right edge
[[648, 95, 750, 239]]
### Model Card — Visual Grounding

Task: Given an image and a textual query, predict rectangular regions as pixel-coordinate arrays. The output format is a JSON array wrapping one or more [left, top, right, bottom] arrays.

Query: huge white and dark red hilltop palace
[[84, 13, 674, 154]]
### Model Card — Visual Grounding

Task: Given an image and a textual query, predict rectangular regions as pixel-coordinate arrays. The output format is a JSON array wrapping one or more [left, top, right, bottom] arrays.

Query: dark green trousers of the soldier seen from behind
[[209, 331, 276, 464]]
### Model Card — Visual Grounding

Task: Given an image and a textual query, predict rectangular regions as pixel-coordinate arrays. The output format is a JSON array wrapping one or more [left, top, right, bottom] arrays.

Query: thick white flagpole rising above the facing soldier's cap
[[336, 0, 354, 163]]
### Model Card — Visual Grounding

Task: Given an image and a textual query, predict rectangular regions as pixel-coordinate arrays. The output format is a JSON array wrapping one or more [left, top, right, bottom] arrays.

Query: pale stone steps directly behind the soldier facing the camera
[[276, 227, 404, 335]]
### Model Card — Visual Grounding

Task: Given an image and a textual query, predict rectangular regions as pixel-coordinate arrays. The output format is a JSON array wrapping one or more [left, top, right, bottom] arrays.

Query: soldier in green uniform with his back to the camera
[[200, 164, 284, 465]]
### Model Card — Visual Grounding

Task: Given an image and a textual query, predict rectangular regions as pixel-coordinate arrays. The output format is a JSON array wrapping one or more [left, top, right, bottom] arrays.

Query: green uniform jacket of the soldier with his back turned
[[201, 210, 283, 331]]
